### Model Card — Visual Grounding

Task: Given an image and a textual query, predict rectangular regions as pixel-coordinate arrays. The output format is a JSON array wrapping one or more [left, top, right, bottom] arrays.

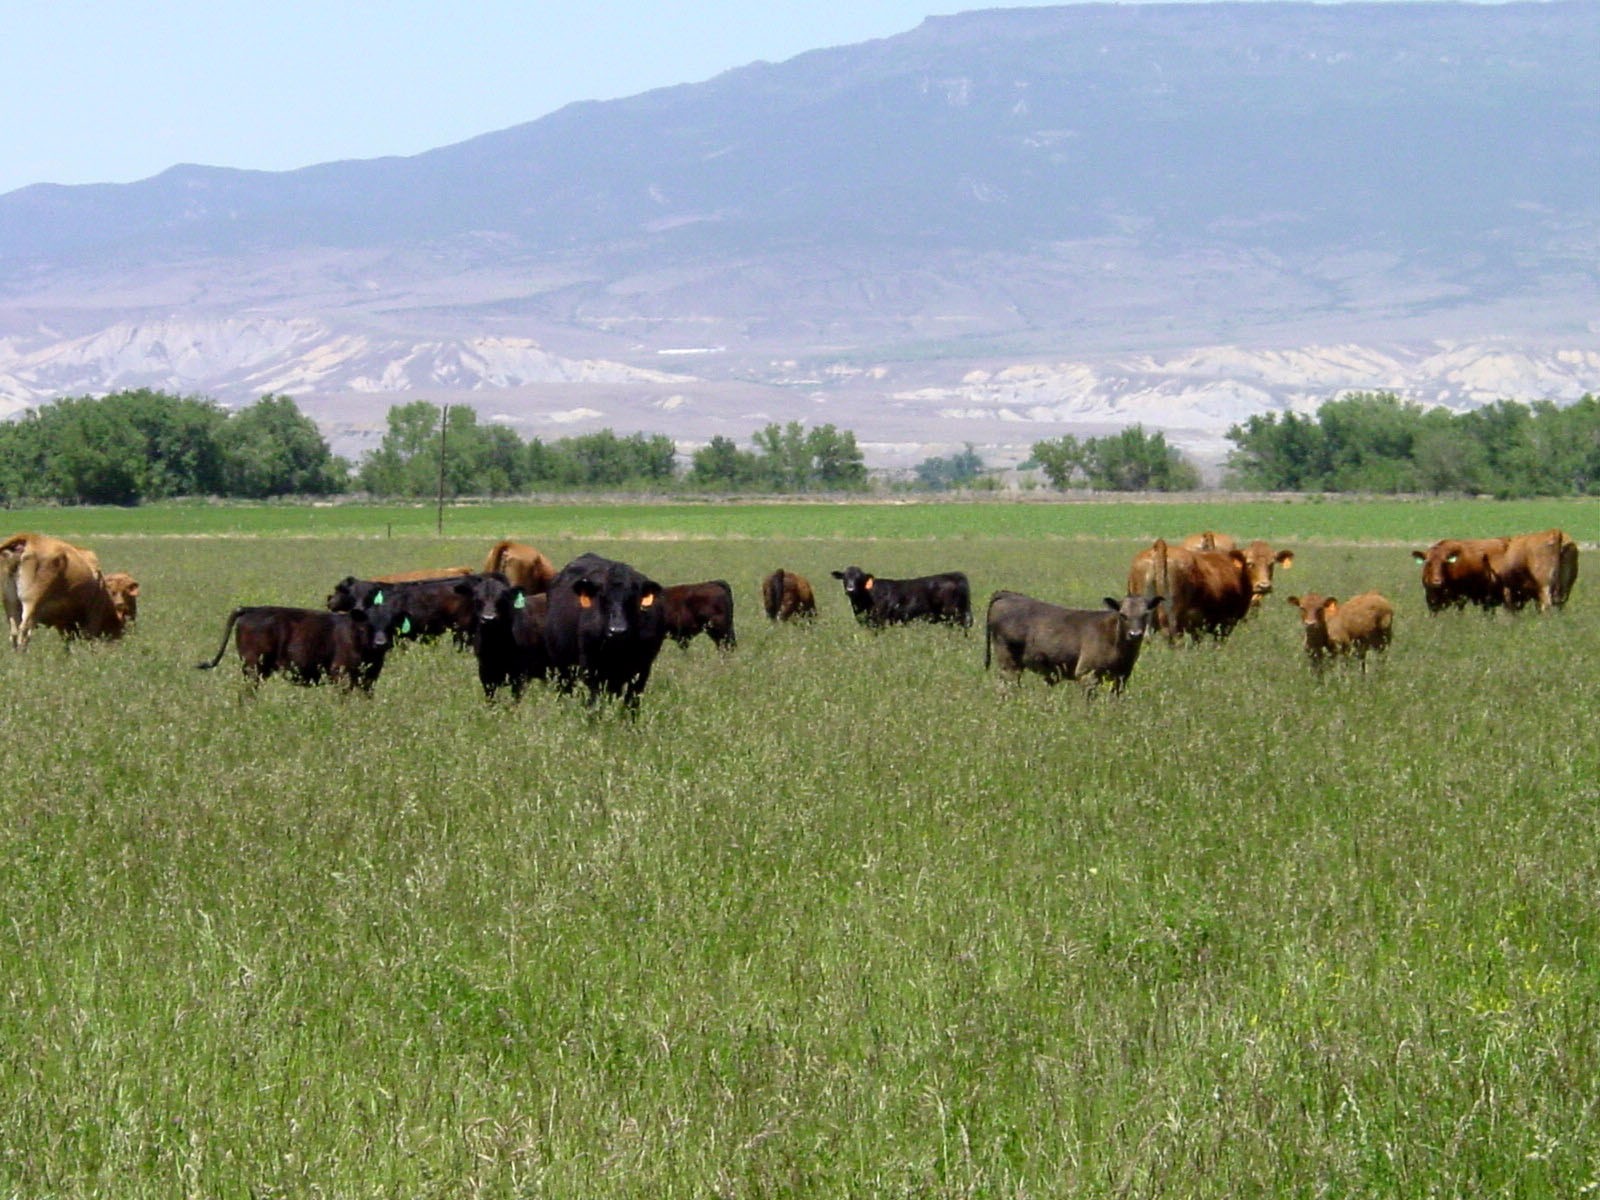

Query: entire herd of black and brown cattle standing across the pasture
[[0, 530, 1578, 707]]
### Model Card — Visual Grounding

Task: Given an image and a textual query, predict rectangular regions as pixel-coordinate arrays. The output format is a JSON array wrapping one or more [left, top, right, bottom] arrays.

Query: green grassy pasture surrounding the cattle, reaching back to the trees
[[0, 501, 1600, 1198]]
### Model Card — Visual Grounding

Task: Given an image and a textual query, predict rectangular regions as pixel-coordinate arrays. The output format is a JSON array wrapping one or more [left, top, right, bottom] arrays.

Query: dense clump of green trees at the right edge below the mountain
[[1227, 392, 1600, 499]]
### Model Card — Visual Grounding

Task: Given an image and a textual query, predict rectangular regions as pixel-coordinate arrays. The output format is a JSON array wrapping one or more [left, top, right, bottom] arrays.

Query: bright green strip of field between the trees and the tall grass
[[6, 499, 1600, 544]]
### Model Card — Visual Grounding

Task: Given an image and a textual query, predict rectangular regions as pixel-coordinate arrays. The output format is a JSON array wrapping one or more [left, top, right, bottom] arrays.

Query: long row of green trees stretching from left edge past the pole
[[0, 389, 867, 506]]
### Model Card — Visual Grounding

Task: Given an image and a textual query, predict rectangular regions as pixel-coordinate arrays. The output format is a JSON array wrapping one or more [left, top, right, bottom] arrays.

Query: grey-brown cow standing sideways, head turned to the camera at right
[[984, 592, 1162, 693]]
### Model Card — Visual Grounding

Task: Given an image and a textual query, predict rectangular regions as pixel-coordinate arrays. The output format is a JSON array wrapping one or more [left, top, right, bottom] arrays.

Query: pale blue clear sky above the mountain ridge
[[0, 0, 1094, 194]]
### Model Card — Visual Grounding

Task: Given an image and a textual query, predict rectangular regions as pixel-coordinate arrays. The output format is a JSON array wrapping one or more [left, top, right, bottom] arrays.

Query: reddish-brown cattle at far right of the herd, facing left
[[1411, 530, 1578, 613]]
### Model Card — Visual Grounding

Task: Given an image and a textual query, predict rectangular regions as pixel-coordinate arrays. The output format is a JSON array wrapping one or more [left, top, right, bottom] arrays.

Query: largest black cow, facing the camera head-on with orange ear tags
[[544, 554, 667, 709]]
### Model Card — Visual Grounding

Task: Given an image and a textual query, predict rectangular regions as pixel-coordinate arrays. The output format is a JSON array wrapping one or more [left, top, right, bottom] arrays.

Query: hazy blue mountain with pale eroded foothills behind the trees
[[0, 0, 1600, 458]]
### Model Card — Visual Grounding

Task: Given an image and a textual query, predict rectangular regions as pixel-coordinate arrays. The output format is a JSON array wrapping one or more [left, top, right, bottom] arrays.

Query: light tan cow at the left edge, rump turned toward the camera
[[0, 533, 139, 650]]
